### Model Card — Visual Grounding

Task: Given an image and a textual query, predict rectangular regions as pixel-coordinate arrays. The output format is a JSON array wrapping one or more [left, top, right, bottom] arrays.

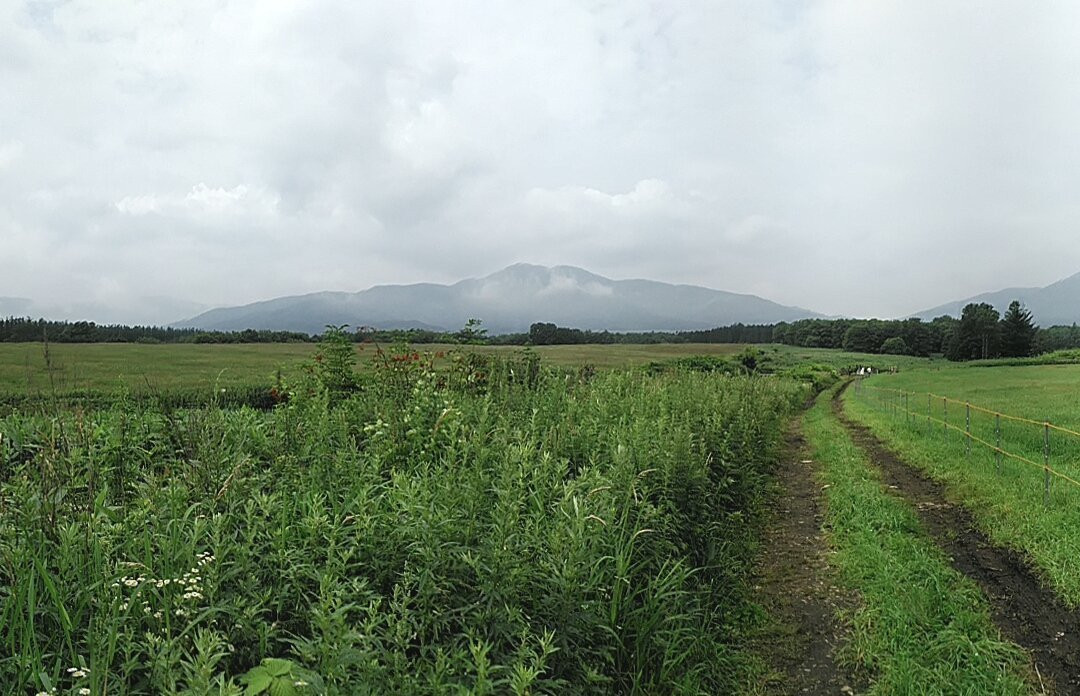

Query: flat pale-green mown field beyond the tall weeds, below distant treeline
[[0, 343, 927, 393]]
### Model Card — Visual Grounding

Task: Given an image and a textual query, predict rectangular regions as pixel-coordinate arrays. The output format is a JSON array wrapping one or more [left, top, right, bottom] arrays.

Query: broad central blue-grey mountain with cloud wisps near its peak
[[174, 264, 821, 334]]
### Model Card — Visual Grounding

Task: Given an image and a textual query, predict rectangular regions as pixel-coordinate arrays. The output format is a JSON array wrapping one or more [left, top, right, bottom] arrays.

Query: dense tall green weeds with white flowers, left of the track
[[0, 342, 809, 694]]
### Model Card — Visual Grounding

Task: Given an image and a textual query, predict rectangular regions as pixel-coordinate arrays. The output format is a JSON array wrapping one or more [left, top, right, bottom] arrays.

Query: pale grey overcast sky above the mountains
[[0, 0, 1080, 321]]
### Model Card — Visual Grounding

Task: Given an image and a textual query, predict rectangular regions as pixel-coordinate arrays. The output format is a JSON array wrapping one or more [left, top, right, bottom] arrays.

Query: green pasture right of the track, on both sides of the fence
[[846, 365, 1080, 605]]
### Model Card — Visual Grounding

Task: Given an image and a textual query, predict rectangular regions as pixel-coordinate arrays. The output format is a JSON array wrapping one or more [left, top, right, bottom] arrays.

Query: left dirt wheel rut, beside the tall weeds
[[758, 424, 852, 695]]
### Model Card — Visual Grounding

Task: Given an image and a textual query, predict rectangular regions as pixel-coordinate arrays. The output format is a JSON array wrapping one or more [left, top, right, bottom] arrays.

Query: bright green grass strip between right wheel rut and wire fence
[[845, 386, 1080, 606]]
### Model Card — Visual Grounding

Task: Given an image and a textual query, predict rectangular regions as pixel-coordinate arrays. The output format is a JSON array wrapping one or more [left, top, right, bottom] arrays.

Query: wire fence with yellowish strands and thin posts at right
[[854, 379, 1080, 506]]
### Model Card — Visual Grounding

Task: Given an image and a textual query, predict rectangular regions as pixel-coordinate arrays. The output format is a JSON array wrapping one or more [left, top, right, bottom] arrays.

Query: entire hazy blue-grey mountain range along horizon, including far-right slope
[[12, 264, 1080, 334]]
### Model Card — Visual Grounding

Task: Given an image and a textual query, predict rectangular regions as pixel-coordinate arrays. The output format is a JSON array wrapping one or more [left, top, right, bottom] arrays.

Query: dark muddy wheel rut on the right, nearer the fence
[[833, 382, 1080, 694]]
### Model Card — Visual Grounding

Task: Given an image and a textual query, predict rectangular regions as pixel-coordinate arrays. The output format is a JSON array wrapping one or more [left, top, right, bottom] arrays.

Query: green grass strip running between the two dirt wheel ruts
[[805, 394, 1029, 696]]
